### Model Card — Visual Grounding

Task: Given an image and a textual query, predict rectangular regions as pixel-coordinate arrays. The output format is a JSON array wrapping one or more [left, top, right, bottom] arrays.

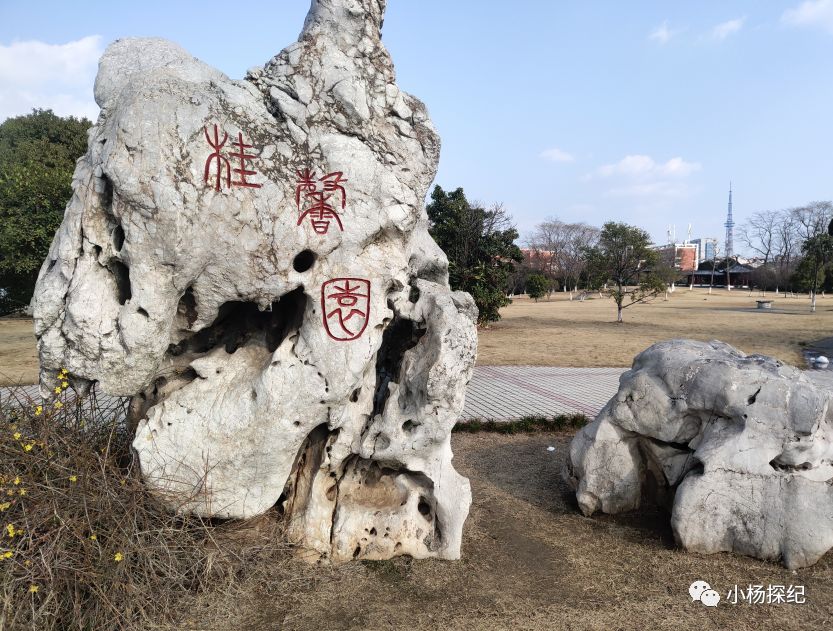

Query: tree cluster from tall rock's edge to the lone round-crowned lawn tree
[[426, 186, 670, 324]]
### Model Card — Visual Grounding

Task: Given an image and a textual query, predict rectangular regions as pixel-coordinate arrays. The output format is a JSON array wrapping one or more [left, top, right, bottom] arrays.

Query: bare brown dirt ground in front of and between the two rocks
[[179, 433, 833, 631]]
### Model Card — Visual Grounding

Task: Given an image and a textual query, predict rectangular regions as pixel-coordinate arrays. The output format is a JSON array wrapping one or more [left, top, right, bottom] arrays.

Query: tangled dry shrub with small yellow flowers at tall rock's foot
[[0, 382, 303, 631]]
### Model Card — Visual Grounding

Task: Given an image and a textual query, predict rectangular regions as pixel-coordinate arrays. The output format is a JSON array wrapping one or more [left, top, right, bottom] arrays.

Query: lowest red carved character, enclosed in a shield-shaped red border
[[321, 278, 370, 342]]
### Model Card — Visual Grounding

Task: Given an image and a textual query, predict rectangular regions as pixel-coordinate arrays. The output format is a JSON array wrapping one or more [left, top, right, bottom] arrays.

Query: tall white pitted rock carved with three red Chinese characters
[[34, 0, 477, 561]]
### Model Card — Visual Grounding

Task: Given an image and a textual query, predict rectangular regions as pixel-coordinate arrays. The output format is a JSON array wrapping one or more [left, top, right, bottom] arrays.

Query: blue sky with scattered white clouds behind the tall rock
[[0, 0, 833, 249]]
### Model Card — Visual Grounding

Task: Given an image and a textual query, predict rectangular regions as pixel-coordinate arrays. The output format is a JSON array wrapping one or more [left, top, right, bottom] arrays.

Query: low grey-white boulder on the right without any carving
[[564, 340, 833, 568]]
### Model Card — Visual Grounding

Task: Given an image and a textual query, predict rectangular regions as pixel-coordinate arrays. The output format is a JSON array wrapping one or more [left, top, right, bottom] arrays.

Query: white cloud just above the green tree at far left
[[0, 35, 103, 121]]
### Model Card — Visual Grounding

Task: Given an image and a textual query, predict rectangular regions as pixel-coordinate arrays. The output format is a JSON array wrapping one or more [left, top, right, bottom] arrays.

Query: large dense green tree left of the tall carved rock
[[0, 110, 92, 314]]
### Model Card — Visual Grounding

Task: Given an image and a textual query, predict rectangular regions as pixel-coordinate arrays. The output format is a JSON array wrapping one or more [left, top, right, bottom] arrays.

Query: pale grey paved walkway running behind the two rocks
[[0, 366, 625, 421]]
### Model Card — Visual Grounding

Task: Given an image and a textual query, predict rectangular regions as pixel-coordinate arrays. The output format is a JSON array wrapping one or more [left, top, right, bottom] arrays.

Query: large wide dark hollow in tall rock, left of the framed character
[[168, 286, 307, 355]]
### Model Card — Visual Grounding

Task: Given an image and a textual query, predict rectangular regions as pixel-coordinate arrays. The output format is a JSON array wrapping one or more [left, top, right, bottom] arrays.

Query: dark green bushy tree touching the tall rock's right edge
[[426, 186, 523, 324]]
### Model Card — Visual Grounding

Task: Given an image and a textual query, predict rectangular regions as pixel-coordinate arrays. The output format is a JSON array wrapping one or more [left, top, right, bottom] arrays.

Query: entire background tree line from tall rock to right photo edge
[[427, 186, 833, 324]]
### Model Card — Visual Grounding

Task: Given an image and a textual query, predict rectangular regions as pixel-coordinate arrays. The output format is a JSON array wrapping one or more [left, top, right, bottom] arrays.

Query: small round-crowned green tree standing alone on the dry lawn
[[585, 221, 666, 322]]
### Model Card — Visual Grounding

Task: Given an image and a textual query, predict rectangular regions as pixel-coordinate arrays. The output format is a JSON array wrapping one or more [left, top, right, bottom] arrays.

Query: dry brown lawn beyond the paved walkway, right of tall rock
[[477, 288, 833, 367]]
